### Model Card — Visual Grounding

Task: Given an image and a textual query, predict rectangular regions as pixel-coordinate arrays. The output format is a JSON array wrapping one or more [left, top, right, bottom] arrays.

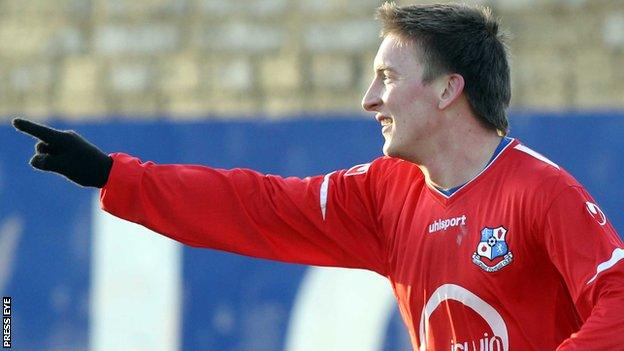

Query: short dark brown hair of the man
[[377, 3, 511, 133]]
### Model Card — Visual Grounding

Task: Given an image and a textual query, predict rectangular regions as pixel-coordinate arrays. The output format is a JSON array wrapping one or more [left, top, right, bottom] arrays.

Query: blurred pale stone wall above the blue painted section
[[0, 0, 624, 120]]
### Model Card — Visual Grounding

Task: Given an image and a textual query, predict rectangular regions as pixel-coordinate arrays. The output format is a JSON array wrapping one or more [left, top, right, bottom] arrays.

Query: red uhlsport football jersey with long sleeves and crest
[[101, 140, 624, 351]]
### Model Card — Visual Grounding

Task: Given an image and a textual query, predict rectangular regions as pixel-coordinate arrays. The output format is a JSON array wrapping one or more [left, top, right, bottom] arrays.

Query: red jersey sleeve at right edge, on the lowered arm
[[543, 185, 624, 351]]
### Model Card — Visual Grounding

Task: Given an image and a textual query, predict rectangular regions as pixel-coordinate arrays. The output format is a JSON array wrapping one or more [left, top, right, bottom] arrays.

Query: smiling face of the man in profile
[[362, 35, 442, 162]]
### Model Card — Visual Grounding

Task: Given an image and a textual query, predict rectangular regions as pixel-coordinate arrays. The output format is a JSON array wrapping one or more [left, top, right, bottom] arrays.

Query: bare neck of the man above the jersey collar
[[417, 126, 502, 189]]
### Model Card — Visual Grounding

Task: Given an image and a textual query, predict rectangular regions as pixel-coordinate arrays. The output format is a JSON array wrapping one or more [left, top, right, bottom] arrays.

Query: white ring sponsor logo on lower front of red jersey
[[419, 284, 509, 351]]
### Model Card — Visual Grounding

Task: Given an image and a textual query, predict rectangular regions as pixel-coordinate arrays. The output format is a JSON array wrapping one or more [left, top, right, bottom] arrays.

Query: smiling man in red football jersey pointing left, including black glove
[[14, 4, 624, 351]]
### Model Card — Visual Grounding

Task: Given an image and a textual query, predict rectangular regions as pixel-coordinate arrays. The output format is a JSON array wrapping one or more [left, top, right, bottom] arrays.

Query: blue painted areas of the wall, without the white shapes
[[0, 113, 624, 351]]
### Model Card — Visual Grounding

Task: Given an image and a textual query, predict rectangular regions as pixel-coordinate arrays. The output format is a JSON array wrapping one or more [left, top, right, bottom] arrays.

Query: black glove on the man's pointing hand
[[13, 118, 113, 188]]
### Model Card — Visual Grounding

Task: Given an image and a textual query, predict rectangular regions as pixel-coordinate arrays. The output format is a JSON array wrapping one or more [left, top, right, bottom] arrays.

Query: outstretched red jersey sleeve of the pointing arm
[[100, 154, 386, 275]]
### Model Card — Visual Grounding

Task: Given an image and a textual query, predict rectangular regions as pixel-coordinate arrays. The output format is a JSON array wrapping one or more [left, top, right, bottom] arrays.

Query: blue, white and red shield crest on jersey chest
[[472, 226, 513, 272]]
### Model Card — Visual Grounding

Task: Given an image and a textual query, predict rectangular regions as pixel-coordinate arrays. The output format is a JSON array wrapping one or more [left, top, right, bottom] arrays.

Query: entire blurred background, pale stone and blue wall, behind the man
[[0, 0, 624, 351]]
